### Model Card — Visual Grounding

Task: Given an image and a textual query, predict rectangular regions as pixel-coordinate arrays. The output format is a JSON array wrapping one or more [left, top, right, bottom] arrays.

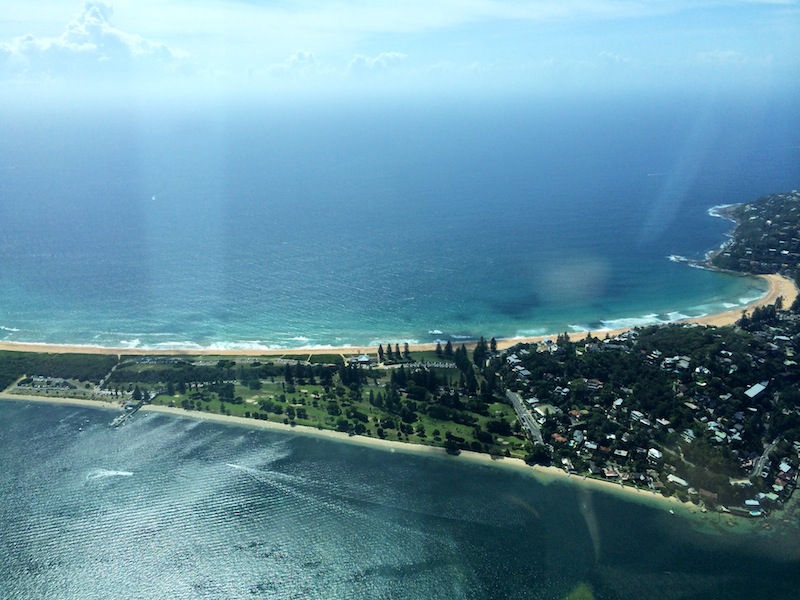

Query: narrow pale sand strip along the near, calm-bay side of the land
[[0, 392, 700, 516]]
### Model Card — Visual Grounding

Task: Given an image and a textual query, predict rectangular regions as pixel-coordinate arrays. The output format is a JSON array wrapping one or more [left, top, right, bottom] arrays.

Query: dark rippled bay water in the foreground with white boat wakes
[[0, 401, 800, 600]]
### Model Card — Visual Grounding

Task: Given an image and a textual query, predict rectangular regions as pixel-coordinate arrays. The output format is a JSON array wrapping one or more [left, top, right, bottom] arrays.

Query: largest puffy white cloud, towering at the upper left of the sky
[[0, 2, 183, 77]]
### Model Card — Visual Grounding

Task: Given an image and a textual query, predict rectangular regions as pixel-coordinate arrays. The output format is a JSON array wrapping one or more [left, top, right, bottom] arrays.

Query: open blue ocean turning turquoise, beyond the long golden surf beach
[[0, 95, 800, 348]]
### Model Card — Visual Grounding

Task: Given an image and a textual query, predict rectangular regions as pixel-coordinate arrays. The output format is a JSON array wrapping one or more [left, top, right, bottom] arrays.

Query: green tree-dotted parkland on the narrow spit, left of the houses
[[4, 345, 524, 456]]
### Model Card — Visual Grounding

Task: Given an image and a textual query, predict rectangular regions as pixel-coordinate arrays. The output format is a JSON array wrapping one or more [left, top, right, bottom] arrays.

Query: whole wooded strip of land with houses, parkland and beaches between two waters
[[0, 192, 800, 516]]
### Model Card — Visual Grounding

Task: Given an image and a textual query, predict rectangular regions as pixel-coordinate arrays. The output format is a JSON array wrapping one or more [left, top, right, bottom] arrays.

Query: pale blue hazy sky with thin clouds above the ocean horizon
[[0, 0, 800, 99]]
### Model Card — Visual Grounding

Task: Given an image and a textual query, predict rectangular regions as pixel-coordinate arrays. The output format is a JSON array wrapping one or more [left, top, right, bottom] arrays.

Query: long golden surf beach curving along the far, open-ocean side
[[0, 273, 799, 357]]
